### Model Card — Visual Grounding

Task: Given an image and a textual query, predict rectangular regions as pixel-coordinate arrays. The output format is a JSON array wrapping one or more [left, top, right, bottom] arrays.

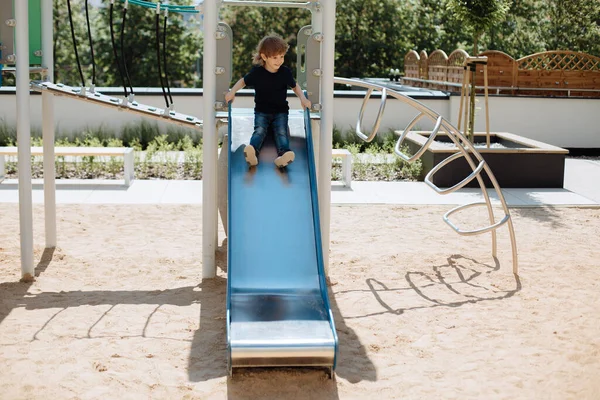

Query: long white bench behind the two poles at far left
[[0, 147, 134, 186]]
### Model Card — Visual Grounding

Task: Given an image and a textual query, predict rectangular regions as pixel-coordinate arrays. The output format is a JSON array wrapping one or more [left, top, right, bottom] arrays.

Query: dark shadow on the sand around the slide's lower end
[[188, 239, 376, 399]]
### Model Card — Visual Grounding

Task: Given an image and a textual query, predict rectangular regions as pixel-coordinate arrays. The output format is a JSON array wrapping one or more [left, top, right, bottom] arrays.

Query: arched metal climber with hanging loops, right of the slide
[[334, 77, 518, 274]]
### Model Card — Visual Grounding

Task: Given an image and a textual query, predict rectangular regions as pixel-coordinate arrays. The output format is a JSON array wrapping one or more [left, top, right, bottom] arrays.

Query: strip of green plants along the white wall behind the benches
[[0, 121, 422, 181]]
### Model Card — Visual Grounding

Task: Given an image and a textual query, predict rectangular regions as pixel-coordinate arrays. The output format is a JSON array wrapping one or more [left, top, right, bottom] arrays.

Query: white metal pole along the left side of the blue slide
[[202, 0, 219, 278]]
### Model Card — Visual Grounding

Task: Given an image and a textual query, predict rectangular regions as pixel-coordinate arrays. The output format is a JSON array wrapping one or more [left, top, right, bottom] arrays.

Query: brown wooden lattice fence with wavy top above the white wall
[[404, 49, 600, 97]]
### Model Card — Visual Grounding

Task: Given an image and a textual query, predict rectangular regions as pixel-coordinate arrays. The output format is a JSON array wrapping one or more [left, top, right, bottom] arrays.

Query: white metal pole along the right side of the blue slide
[[319, 0, 336, 271]]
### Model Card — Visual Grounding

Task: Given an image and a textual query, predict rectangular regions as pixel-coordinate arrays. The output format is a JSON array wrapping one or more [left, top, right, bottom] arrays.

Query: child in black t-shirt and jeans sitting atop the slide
[[225, 35, 311, 168]]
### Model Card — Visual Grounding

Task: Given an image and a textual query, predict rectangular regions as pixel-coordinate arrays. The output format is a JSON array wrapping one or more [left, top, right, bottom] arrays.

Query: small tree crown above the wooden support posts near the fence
[[448, 0, 510, 54]]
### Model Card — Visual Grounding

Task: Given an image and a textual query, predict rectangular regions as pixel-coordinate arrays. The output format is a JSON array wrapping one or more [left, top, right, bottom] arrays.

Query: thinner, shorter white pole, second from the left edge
[[41, 0, 56, 248]]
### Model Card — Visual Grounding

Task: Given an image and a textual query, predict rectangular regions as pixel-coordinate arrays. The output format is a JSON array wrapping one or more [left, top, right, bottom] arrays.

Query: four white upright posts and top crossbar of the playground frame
[[8, 0, 336, 281]]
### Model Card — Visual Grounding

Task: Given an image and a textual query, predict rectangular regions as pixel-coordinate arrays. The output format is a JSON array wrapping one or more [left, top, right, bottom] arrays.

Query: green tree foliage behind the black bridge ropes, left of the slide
[[54, 0, 202, 87]]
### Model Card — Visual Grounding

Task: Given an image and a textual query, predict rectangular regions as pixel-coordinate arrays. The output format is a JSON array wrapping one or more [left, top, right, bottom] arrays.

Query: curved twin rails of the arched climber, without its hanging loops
[[334, 77, 518, 275]]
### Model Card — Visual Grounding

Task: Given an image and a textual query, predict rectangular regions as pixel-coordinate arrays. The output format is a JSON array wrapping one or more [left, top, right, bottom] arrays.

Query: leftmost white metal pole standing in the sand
[[14, 1, 34, 281]]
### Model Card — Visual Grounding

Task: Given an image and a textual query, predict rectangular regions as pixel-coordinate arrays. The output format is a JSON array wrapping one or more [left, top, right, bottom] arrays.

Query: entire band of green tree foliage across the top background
[[31, 0, 600, 87]]
